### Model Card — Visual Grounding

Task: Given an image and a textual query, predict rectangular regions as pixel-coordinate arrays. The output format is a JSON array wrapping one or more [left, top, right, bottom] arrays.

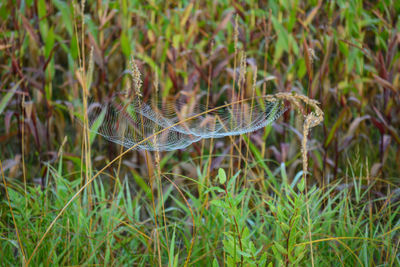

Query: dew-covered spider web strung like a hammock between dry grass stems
[[84, 97, 285, 151]]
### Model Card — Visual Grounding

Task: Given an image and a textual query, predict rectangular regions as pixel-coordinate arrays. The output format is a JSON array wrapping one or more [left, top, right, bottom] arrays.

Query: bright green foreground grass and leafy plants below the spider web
[[1, 159, 400, 266]]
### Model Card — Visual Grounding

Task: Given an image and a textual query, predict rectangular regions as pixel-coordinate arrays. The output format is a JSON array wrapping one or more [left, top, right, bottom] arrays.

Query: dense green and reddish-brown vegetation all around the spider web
[[0, 0, 400, 266]]
